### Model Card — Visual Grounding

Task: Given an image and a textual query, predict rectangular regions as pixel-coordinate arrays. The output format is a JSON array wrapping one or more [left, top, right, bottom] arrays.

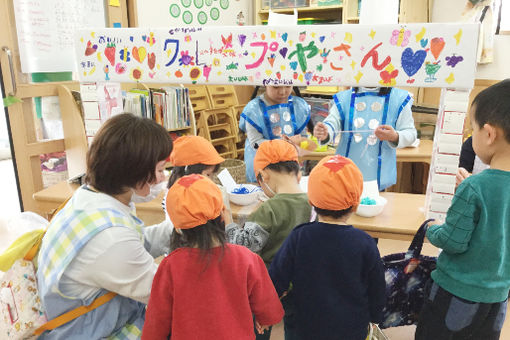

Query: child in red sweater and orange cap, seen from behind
[[142, 174, 283, 340]]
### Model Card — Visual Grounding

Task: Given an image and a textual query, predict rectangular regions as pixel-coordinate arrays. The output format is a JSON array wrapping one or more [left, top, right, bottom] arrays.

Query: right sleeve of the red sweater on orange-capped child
[[248, 254, 284, 326]]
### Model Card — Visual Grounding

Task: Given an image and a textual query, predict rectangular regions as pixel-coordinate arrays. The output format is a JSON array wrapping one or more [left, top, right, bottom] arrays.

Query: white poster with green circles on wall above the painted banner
[[136, 0, 251, 27]]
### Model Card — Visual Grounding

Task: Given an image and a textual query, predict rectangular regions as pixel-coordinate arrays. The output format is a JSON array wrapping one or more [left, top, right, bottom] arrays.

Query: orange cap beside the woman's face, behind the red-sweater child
[[170, 136, 225, 166]]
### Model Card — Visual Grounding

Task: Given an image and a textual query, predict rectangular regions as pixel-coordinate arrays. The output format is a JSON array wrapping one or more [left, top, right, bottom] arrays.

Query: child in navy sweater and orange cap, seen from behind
[[269, 155, 386, 340]]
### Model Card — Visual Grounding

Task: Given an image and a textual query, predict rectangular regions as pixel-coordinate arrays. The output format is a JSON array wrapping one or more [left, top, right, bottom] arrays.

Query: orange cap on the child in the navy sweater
[[308, 155, 363, 210]]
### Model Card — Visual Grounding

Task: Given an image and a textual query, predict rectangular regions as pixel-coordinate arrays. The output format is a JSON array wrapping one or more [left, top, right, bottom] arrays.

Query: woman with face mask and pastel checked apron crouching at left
[[37, 114, 172, 339]]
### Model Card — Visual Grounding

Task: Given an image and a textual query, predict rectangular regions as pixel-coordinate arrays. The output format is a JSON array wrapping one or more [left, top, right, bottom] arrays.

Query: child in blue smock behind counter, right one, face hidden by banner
[[314, 87, 416, 190]]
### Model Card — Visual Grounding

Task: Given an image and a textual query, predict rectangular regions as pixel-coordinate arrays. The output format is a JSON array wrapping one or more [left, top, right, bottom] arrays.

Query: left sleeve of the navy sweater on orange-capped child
[[269, 231, 296, 296]]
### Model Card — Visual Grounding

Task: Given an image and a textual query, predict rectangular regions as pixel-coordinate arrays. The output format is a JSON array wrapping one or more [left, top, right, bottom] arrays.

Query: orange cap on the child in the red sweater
[[166, 174, 223, 229]]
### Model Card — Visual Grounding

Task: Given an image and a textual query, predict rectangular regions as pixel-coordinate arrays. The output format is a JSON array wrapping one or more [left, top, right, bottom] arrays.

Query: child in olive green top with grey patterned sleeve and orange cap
[[227, 139, 312, 339]]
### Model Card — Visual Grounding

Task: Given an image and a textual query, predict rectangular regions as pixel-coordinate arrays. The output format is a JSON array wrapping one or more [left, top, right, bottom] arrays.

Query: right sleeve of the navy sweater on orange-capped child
[[368, 240, 386, 323]]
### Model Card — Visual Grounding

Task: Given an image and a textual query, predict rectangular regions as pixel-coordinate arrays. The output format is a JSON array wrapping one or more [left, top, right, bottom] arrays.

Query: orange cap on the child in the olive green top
[[253, 139, 298, 175]]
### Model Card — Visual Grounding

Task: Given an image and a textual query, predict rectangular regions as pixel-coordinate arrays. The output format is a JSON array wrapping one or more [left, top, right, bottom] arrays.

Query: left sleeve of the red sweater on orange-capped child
[[142, 257, 173, 340]]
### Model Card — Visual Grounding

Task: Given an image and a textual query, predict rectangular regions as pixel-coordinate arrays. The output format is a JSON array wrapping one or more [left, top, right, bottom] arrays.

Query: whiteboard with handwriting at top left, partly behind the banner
[[14, 0, 106, 73]]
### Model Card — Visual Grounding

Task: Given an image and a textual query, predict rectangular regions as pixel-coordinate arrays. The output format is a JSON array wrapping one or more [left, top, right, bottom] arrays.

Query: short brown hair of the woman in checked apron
[[85, 113, 172, 195]]
